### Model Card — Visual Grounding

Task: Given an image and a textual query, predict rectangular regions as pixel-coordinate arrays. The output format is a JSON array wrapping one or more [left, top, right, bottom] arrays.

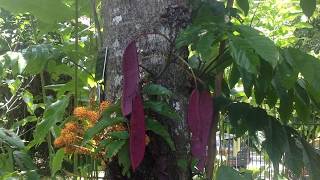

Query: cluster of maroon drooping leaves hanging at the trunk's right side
[[187, 89, 213, 170]]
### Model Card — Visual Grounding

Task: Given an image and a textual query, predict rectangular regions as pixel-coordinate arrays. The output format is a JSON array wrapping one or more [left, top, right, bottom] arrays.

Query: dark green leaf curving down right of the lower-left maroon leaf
[[146, 119, 176, 151]]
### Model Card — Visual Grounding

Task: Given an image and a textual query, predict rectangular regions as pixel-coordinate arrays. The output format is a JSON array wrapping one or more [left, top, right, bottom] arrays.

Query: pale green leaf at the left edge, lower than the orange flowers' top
[[0, 128, 25, 149]]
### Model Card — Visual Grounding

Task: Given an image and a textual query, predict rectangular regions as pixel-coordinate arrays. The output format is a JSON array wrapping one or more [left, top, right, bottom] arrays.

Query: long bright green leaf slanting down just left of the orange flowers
[[28, 96, 69, 148]]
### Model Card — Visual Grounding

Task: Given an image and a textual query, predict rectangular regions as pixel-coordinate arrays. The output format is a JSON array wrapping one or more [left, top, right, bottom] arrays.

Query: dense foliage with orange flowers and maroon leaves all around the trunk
[[0, 0, 320, 180]]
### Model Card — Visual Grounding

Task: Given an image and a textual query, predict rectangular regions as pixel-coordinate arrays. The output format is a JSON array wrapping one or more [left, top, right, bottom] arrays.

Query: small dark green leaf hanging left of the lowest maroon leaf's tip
[[118, 143, 131, 177]]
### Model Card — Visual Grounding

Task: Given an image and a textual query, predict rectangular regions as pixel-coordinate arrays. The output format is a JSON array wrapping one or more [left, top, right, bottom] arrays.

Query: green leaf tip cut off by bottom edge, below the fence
[[216, 165, 246, 180]]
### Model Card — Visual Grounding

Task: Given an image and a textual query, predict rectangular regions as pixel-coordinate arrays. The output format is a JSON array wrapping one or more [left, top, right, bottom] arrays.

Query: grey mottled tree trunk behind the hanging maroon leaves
[[103, 0, 191, 180]]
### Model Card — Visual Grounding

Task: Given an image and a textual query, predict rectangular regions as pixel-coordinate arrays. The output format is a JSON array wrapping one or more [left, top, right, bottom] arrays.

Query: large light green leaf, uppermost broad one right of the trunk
[[236, 25, 281, 68]]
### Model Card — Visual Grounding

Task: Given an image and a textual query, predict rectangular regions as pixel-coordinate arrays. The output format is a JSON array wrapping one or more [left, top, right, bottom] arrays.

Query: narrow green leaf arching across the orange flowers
[[82, 116, 125, 144]]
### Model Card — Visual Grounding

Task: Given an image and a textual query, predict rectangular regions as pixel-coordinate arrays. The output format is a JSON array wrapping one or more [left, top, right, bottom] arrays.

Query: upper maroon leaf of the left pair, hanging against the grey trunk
[[121, 41, 139, 116]]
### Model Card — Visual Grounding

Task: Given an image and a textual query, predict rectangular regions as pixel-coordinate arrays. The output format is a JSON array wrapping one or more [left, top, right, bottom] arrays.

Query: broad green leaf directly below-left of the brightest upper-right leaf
[[229, 36, 260, 74]]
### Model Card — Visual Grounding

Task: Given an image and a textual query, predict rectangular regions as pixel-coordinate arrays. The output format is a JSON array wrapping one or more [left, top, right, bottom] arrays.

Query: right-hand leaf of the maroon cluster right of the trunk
[[197, 91, 214, 169]]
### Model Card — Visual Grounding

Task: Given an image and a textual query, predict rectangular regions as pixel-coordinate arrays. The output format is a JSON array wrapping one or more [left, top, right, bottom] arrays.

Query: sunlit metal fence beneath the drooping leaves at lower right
[[216, 124, 320, 180]]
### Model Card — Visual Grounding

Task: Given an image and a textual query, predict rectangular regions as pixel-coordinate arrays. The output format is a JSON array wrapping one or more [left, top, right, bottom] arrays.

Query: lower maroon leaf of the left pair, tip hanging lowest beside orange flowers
[[130, 94, 146, 171]]
